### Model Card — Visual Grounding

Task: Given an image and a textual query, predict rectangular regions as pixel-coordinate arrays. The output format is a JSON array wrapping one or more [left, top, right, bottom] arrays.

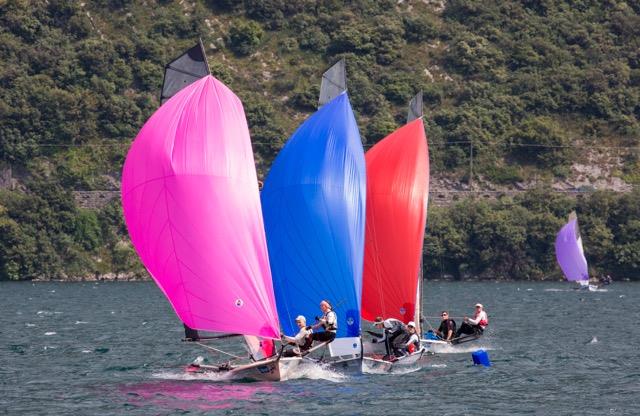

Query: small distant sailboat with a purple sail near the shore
[[556, 212, 598, 292]]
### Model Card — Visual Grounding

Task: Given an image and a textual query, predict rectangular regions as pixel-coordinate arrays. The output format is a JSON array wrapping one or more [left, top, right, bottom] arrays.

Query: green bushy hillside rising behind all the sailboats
[[0, 0, 640, 279]]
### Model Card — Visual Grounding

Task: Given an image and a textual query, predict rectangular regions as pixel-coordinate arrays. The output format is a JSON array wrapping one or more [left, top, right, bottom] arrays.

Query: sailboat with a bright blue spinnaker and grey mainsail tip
[[261, 60, 366, 373]]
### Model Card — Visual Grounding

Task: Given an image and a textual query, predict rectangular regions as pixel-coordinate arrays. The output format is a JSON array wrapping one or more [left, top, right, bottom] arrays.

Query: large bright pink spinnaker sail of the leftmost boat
[[122, 75, 280, 338]]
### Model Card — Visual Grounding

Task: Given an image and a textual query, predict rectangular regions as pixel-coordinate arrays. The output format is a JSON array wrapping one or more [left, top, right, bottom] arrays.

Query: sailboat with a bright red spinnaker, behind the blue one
[[362, 93, 429, 371]]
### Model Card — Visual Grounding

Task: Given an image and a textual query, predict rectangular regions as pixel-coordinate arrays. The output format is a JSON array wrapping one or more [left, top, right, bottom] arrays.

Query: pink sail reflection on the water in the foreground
[[119, 381, 275, 410]]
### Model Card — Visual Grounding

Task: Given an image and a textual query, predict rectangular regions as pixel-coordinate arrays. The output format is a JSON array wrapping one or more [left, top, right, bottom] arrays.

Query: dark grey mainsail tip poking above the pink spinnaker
[[160, 39, 211, 104]]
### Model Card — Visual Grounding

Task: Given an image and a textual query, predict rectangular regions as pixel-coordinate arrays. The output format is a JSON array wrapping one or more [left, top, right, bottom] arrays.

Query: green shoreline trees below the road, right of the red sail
[[423, 189, 640, 280]]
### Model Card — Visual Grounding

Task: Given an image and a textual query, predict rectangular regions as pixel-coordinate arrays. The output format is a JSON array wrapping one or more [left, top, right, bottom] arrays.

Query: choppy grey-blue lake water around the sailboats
[[0, 282, 640, 415]]
